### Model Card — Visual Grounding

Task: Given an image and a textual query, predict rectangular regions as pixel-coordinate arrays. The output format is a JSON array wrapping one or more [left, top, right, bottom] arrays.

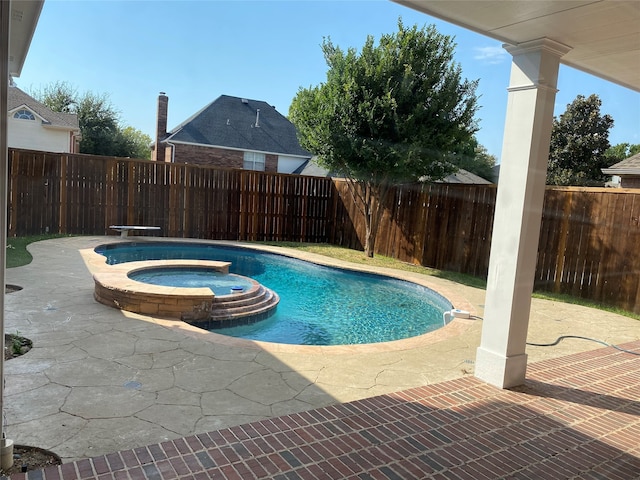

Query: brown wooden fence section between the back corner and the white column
[[336, 182, 496, 277]]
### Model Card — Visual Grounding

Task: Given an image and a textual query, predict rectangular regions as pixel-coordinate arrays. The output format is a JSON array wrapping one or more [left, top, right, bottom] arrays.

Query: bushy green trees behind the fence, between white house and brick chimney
[[31, 82, 151, 159]]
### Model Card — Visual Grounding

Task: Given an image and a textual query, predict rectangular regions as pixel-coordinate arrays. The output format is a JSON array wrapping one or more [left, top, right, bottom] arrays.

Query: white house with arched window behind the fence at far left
[[7, 85, 80, 153]]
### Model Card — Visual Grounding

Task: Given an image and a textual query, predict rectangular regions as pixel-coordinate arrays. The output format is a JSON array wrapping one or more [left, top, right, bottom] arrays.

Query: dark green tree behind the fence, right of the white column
[[547, 94, 613, 186]]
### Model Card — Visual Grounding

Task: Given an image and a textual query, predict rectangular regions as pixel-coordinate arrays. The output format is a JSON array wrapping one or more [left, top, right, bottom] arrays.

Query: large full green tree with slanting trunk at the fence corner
[[289, 20, 478, 257]]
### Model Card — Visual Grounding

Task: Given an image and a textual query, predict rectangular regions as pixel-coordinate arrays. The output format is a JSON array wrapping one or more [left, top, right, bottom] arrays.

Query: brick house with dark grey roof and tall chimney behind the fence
[[151, 92, 311, 173]]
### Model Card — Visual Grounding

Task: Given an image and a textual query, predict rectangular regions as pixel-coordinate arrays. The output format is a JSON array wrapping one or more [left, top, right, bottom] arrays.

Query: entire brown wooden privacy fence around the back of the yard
[[8, 149, 640, 313]]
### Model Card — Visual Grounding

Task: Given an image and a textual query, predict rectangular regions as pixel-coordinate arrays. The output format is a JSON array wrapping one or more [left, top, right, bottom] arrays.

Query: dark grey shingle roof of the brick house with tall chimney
[[165, 95, 311, 158]]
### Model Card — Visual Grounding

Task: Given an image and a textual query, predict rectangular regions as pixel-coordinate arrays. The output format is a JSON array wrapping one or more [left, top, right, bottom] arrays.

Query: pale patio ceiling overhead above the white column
[[394, 0, 640, 91]]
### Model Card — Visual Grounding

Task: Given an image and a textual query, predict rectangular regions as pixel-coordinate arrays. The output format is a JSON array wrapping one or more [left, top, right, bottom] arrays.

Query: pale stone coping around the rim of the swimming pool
[[80, 237, 477, 354]]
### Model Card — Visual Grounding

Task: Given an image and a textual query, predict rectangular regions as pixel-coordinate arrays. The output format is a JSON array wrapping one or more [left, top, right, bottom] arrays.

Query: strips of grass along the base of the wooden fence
[[7, 235, 640, 320]]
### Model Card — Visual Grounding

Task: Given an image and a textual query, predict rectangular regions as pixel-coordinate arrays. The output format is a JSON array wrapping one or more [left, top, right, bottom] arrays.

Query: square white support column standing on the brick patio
[[475, 39, 569, 388]]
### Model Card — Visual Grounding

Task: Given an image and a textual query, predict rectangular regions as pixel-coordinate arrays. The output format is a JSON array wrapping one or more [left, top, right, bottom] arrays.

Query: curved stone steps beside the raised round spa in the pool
[[190, 284, 280, 329]]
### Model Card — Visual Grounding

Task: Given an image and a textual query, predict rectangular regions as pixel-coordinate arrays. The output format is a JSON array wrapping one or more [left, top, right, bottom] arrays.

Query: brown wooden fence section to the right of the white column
[[535, 188, 640, 313]]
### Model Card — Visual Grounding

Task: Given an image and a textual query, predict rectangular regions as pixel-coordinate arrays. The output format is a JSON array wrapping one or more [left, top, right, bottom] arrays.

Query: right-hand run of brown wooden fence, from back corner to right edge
[[337, 184, 640, 313]]
